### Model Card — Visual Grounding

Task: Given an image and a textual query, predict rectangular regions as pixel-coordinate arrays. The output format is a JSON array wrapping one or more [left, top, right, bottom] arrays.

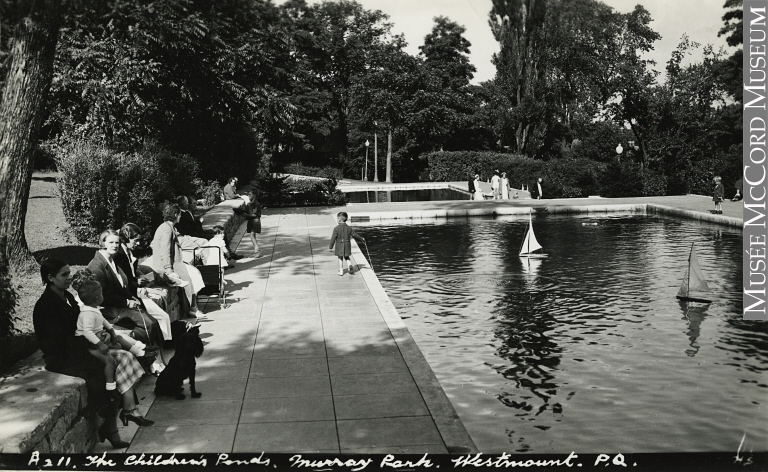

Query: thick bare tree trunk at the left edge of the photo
[[0, 0, 60, 269]]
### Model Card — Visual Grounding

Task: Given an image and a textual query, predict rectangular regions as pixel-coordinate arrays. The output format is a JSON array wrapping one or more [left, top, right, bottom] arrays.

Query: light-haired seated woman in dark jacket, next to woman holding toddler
[[88, 229, 165, 374]]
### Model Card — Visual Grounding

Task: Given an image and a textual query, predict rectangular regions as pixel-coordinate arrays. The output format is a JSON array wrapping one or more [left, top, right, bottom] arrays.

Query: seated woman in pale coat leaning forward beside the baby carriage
[[147, 203, 205, 316]]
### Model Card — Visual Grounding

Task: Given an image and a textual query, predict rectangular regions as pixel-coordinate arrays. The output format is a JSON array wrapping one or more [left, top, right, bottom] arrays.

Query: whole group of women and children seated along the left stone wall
[[33, 184, 258, 448]]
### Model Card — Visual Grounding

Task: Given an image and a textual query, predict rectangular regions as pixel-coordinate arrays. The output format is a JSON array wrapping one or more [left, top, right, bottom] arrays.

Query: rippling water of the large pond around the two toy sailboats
[[360, 214, 768, 454]]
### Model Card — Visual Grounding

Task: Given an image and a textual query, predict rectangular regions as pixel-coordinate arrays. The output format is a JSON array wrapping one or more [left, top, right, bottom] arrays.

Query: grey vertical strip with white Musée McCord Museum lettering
[[743, 0, 768, 321]]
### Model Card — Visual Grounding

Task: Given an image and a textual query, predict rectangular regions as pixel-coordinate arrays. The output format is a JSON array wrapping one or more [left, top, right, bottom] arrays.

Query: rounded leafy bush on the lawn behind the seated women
[[51, 141, 197, 241]]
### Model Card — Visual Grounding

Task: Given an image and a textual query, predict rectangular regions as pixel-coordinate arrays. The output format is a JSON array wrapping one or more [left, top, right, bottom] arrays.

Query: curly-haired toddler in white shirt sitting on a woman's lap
[[73, 273, 153, 395]]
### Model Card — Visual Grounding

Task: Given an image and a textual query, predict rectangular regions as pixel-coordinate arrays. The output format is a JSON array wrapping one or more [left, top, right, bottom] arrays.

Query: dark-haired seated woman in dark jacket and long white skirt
[[114, 223, 176, 341]]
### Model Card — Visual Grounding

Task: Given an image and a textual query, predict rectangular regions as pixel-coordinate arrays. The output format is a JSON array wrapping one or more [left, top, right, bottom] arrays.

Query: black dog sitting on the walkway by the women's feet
[[155, 326, 203, 400]]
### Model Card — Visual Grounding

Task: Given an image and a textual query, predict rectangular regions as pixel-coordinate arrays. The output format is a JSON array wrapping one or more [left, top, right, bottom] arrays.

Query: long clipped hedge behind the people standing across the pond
[[421, 151, 605, 198]]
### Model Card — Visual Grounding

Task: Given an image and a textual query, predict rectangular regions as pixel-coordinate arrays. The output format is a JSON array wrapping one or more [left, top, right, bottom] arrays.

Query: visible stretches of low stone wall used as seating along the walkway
[[0, 200, 245, 454]]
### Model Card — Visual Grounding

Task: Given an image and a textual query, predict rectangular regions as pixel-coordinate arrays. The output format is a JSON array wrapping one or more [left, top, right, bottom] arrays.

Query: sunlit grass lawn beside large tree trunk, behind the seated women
[[0, 172, 98, 370]]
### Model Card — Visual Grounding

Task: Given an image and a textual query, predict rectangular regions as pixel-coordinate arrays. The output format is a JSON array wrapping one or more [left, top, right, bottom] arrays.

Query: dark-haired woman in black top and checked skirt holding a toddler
[[32, 259, 153, 448]]
